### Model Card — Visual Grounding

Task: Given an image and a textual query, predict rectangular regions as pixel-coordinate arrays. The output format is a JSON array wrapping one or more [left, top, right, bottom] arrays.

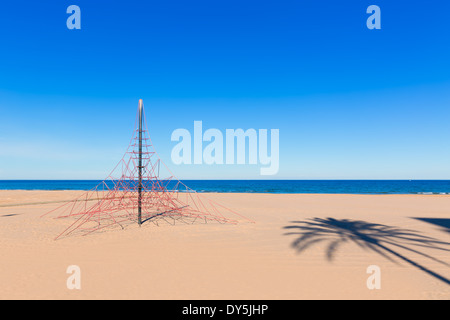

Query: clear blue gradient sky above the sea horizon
[[0, 0, 450, 179]]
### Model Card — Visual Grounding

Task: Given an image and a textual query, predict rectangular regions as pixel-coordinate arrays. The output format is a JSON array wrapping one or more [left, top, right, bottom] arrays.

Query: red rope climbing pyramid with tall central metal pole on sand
[[45, 100, 252, 239]]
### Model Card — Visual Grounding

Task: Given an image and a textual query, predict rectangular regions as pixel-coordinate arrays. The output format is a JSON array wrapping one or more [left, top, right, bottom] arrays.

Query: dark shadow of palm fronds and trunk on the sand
[[284, 218, 450, 285]]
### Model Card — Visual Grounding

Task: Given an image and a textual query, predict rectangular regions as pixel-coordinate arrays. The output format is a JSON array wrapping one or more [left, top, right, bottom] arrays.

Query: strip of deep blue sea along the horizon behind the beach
[[0, 180, 450, 194]]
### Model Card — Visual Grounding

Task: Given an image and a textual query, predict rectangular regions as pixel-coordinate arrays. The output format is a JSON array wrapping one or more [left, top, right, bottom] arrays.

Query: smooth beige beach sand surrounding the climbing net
[[0, 191, 450, 300]]
